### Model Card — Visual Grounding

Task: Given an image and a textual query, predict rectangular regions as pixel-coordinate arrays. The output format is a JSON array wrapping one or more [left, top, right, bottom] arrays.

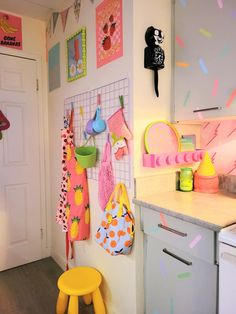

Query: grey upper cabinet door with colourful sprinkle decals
[[173, 0, 236, 121]]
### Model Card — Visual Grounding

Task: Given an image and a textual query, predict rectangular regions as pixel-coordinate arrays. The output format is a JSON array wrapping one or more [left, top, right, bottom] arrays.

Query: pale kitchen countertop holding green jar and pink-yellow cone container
[[133, 191, 236, 231]]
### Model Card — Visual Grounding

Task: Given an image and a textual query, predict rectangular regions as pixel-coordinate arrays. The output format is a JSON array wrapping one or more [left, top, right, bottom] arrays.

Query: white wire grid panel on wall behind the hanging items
[[64, 78, 131, 188]]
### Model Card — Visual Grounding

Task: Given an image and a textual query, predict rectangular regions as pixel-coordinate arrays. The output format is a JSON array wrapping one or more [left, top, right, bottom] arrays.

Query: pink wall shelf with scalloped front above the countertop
[[143, 149, 204, 168]]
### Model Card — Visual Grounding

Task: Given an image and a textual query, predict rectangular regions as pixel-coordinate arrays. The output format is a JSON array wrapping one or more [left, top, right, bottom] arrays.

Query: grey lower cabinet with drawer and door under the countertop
[[141, 207, 218, 314]]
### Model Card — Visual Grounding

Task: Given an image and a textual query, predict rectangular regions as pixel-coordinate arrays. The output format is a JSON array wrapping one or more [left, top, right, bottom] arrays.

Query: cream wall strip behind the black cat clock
[[133, 0, 171, 177]]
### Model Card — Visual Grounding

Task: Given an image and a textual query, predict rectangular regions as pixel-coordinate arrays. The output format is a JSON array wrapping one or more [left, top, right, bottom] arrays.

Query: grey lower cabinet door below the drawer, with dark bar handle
[[145, 236, 217, 314]]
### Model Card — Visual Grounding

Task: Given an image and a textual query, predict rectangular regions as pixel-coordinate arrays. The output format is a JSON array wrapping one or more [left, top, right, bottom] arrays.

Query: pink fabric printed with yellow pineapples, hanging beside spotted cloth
[[66, 139, 90, 241]]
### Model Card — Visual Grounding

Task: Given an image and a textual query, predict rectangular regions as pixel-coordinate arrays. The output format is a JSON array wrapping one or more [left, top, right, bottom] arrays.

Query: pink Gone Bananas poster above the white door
[[0, 12, 22, 50]]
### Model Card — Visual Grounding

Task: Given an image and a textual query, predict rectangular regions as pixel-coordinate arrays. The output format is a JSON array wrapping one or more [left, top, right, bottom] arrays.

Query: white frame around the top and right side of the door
[[0, 47, 51, 258]]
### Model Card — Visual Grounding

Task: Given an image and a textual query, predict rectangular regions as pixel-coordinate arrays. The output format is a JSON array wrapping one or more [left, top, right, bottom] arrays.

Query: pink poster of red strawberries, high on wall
[[96, 0, 123, 68]]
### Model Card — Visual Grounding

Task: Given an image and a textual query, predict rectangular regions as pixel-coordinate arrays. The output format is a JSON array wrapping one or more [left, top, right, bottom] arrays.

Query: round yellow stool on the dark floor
[[56, 266, 106, 314]]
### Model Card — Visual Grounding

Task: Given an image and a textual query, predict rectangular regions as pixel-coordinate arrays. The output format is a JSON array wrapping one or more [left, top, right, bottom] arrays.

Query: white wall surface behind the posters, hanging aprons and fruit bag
[[48, 1, 136, 314]]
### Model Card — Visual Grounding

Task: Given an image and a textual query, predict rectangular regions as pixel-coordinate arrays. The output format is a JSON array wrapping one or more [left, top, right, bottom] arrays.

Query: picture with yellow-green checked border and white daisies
[[66, 27, 86, 82]]
